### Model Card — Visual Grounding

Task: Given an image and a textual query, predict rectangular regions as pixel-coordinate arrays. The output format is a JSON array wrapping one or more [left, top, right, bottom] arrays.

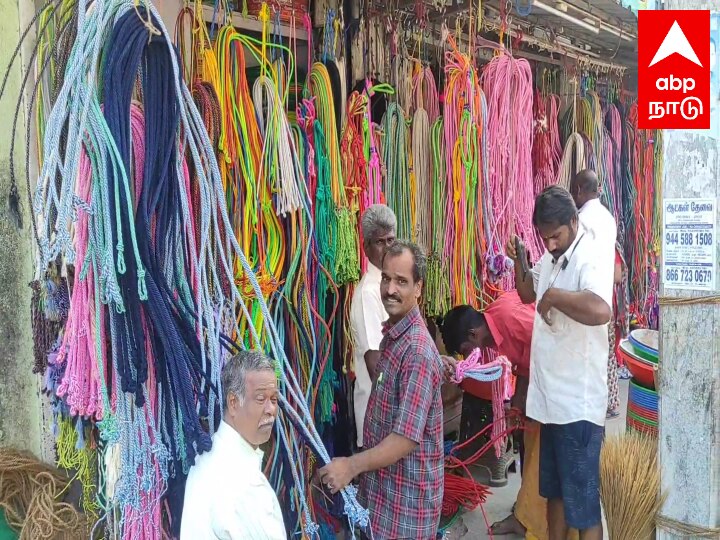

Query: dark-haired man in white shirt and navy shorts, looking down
[[507, 186, 613, 540]]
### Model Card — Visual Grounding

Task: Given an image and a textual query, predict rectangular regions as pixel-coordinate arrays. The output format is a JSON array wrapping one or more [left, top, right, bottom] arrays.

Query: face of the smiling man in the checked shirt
[[380, 250, 422, 323]]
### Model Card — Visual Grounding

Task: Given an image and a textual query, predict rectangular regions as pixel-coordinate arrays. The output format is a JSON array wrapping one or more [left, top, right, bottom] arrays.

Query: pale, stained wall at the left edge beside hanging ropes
[[0, 0, 45, 459]]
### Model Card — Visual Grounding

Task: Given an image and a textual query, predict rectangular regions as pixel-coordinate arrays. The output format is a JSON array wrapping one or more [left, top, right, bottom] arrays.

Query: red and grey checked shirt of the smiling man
[[360, 308, 444, 540]]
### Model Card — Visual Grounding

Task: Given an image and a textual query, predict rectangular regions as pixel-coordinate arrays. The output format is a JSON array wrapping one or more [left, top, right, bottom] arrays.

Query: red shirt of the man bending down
[[483, 291, 535, 377]]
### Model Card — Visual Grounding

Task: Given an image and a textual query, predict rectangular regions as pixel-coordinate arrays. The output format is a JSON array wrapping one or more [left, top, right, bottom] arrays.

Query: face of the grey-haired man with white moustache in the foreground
[[227, 370, 278, 447]]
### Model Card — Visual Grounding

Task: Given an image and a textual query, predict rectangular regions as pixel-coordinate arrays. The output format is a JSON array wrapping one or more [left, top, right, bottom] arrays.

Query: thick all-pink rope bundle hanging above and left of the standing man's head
[[481, 53, 541, 270]]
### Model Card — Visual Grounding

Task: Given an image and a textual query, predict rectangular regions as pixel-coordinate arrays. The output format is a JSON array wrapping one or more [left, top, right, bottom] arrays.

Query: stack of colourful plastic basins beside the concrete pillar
[[618, 329, 659, 437]]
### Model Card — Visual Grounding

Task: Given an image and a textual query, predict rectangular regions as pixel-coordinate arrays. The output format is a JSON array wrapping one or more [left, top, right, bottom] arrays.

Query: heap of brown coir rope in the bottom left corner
[[0, 448, 89, 540]]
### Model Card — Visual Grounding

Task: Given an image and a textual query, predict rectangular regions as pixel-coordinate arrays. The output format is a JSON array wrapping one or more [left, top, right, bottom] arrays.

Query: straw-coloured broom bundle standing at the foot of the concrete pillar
[[600, 433, 663, 540]]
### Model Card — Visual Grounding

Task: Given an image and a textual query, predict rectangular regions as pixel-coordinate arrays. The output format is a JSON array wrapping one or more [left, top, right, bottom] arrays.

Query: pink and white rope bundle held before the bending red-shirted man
[[452, 349, 513, 457]]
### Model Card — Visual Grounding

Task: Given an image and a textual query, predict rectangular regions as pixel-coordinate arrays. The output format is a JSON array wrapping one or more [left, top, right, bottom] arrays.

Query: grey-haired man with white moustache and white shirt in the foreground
[[180, 351, 287, 540]]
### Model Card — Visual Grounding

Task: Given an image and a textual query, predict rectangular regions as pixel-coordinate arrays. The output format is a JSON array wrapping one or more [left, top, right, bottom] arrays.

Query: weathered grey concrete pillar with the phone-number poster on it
[[658, 0, 720, 540]]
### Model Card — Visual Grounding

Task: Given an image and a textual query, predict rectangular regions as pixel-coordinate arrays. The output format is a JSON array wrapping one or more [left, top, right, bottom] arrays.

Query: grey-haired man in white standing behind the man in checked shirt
[[350, 204, 397, 448]]
